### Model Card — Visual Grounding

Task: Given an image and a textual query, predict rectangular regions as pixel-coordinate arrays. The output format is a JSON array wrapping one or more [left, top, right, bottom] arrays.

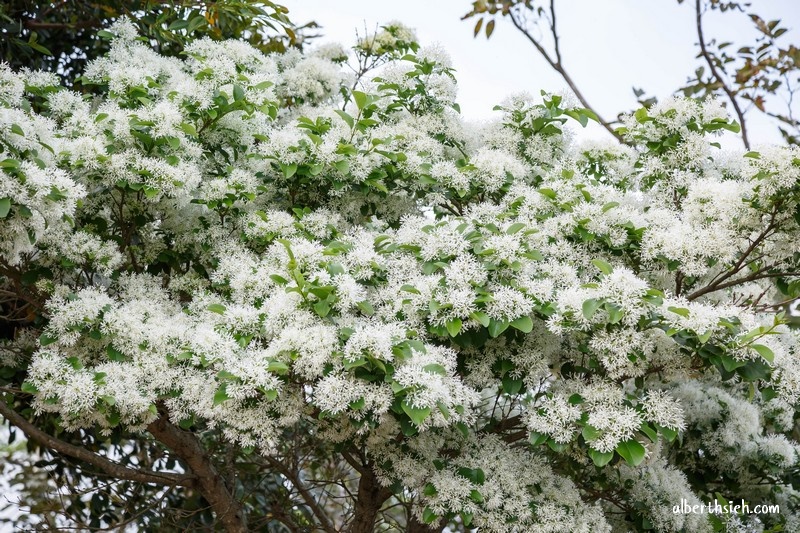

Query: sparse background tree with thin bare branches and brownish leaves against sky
[[463, 0, 800, 149]]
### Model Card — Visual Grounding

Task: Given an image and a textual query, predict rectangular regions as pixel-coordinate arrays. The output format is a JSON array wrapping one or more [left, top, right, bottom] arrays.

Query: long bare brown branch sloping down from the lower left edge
[[0, 401, 189, 486]]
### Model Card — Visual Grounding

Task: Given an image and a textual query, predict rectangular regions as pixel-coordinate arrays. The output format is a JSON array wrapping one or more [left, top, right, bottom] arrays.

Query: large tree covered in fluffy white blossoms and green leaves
[[0, 18, 800, 532]]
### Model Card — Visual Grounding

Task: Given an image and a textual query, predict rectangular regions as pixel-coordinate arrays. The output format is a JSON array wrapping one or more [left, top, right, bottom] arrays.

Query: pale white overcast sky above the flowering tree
[[282, 0, 800, 144]]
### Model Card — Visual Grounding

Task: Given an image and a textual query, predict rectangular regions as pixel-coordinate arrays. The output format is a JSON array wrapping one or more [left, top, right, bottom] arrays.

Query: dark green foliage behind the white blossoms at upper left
[[0, 0, 316, 83]]
